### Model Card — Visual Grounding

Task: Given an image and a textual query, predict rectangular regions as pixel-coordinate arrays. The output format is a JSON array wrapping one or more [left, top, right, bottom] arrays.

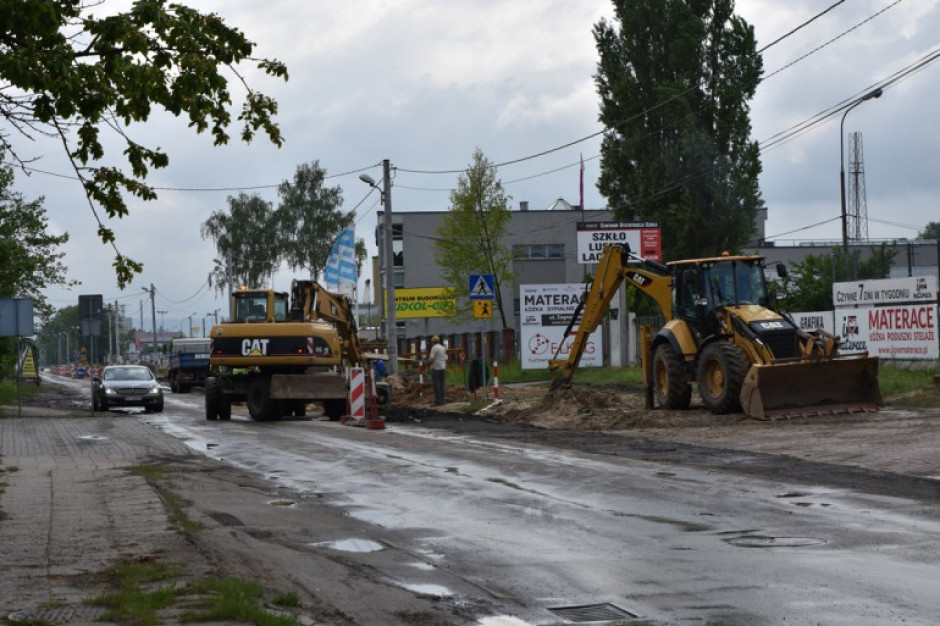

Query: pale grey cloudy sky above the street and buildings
[[9, 0, 940, 330]]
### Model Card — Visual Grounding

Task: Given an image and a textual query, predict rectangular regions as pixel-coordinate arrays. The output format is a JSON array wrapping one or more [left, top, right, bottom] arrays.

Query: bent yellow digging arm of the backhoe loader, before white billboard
[[548, 244, 672, 389]]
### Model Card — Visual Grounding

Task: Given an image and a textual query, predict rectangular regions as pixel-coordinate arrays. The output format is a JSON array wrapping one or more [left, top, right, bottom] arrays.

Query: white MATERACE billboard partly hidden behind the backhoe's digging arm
[[519, 283, 604, 369]]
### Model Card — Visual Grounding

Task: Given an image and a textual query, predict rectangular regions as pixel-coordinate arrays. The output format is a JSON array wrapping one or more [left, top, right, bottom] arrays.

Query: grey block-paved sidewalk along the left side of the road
[[0, 406, 196, 624]]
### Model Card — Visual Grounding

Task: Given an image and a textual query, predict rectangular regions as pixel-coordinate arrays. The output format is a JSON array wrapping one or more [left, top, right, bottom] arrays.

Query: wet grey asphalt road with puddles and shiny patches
[[23, 376, 940, 626]]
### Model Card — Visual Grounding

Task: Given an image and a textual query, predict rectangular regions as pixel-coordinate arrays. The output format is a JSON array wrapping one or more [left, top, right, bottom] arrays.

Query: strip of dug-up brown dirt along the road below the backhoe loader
[[389, 372, 940, 499]]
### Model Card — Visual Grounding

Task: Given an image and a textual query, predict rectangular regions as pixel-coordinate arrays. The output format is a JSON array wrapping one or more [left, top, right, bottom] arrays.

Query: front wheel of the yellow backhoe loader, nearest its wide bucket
[[698, 341, 751, 415]]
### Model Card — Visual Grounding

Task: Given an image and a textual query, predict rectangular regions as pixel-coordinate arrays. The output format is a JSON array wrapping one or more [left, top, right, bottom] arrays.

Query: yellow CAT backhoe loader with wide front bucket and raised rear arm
[[549, 245, 882, 419]]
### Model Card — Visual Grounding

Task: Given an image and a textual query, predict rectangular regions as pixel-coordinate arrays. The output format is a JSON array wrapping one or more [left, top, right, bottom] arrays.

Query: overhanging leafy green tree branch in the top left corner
[[0, 0, 287, 288]]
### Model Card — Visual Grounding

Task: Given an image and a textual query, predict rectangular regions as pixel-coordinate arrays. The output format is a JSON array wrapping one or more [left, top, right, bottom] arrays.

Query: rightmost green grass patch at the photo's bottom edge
[[181, 578, 300, 626]]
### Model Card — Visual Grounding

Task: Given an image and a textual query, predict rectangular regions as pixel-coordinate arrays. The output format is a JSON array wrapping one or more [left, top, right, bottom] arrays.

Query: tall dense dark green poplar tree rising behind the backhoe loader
[[594, 0, 763, 259]]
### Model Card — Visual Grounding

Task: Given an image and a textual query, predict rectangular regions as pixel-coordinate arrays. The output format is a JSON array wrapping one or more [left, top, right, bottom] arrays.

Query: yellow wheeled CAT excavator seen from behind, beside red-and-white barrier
[[205, 280, 388, 421]]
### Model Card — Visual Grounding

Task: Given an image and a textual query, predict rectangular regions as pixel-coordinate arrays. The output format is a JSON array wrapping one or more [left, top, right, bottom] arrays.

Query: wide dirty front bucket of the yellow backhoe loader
[[741, 356, 883, 419]]
